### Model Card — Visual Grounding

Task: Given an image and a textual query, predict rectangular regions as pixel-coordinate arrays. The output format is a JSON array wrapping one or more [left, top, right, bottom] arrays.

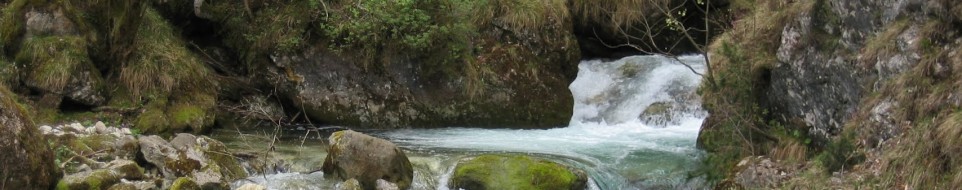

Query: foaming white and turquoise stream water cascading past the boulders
[[221, 56, 707, 189]]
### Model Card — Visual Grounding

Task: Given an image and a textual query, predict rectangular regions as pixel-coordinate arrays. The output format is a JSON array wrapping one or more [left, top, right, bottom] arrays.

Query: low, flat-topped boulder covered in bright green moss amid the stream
[[449, 155, 588, 190]]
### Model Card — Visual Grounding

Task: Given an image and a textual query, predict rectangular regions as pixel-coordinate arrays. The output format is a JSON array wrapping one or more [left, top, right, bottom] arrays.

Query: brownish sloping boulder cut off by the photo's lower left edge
[[0, 86, 60, 189]]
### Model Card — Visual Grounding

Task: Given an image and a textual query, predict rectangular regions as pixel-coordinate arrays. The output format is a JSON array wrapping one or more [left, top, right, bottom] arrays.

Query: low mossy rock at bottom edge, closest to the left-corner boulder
[[57, 169, 121, 190]]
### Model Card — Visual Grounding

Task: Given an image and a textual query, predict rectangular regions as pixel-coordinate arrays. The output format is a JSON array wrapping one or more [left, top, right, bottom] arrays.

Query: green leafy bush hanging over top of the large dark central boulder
[[320, 0, 473, 72]]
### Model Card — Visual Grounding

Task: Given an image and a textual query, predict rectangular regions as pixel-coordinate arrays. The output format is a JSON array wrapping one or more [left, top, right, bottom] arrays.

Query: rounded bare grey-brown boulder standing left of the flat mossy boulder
[[322, 130, 414, 189]]
